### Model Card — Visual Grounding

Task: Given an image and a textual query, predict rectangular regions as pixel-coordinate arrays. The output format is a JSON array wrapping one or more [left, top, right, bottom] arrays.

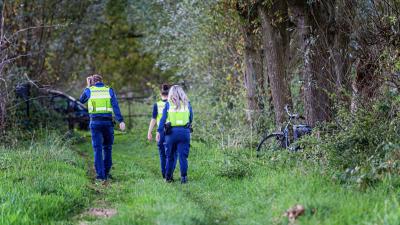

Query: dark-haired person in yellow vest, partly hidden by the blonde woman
[[147, 84, 178, 179]]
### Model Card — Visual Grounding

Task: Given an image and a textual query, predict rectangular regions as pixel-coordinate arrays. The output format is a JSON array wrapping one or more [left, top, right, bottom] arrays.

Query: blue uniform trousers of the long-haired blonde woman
[[165, 127, 190, 179]]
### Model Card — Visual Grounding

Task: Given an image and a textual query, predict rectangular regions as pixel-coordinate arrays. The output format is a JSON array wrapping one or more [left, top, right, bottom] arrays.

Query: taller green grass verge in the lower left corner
[[0, 133, 89, 225]]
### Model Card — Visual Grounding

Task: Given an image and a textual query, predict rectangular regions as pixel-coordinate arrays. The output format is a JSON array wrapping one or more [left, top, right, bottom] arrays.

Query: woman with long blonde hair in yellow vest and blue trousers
[[156, 85, 193, 184]]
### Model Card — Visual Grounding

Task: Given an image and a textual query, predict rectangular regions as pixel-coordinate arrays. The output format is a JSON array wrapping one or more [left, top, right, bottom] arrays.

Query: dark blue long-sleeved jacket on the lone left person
[[79, 83, 124, 123]]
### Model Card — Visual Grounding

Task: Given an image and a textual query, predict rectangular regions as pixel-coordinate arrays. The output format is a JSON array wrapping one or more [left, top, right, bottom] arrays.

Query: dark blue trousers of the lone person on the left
[[90, 121, 114, 180]]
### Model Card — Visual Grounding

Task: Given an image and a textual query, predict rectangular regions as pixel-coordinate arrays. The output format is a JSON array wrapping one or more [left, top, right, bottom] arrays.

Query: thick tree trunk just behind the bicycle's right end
[[289, 0, 336, 126]]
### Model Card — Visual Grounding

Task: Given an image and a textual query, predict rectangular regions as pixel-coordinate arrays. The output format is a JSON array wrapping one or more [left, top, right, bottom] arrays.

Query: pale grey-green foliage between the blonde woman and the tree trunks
[[129, 1, 272, 148]]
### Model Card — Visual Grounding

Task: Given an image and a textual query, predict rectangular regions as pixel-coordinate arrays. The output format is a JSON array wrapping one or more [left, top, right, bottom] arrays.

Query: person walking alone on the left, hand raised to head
[[79, 74, 125, 181]]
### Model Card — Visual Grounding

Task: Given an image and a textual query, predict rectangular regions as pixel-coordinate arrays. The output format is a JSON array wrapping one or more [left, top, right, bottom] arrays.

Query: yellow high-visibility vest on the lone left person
[[88, 86, 113, 114]]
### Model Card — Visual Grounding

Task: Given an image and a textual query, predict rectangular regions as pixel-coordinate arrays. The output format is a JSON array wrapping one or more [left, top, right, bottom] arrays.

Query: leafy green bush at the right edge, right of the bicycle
[[299, 97, 400, 188]]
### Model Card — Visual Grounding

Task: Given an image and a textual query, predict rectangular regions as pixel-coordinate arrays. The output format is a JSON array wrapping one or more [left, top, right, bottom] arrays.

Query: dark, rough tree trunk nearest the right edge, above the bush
[[351, 1, 384, 112]]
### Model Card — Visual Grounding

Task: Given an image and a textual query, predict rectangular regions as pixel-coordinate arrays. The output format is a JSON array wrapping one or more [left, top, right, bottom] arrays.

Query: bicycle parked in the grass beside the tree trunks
[[257, 106, 312, 157]]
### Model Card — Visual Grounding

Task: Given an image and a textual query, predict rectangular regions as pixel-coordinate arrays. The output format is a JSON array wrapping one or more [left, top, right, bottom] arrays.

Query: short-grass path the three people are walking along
[[78, 129, 400, 225]]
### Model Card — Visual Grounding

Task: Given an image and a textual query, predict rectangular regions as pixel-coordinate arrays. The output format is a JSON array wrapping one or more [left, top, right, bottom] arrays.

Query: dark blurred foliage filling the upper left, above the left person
[[0, 0, 173, 133]]
